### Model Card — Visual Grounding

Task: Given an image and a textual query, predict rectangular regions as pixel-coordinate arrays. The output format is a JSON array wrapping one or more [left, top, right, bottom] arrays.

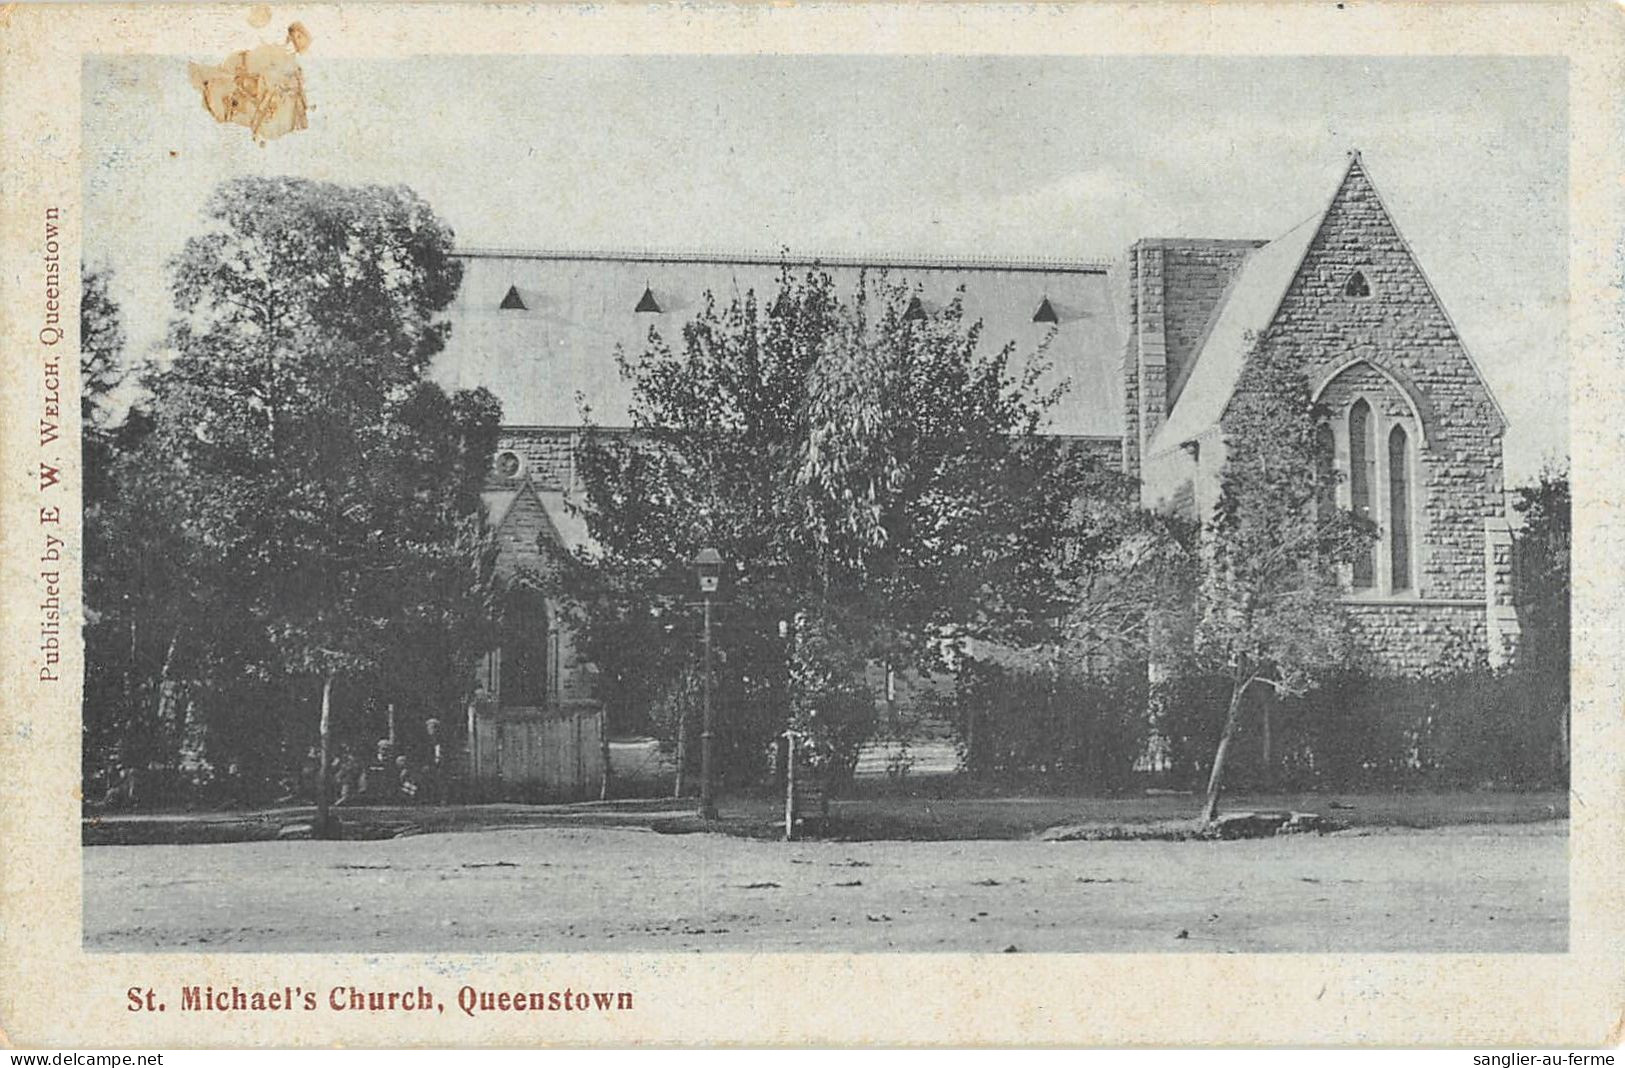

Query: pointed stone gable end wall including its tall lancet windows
[[1263, 154, 1505, 603]]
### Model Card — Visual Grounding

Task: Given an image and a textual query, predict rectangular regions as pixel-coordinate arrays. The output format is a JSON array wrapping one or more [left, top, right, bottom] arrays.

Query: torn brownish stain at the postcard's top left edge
[[187, 22, 310, 145]]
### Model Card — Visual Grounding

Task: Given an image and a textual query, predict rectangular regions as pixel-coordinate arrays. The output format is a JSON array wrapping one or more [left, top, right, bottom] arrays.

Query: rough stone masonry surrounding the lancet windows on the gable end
[[1241, 159, 1505, 671]]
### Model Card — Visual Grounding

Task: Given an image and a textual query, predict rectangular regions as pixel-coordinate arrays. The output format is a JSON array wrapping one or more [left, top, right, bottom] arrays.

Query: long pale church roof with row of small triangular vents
[[432, 249, 1123, 437]]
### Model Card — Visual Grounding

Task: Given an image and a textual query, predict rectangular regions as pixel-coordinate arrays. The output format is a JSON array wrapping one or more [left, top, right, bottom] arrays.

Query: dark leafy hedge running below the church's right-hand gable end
[[938, 663, 1568, 792]]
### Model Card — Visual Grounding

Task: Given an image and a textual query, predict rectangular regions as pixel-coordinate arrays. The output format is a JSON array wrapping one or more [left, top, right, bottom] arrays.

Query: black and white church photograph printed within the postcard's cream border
[[81, 47, 1570, 953]]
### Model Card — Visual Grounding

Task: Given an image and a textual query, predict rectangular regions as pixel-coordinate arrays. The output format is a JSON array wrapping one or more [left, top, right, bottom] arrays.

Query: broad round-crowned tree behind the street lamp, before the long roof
[[575, 268, 1095, 783]]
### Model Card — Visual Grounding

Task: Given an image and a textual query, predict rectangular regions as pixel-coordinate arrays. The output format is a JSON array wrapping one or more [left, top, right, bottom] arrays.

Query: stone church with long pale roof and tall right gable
[[436, 153, 1518, 790]]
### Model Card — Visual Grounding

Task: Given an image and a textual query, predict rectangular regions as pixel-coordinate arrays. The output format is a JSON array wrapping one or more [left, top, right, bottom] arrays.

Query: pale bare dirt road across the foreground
[[83, 821, 1568, 953]]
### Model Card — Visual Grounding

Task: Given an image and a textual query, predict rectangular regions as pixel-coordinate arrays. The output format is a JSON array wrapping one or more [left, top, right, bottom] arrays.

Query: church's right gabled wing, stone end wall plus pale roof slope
[[1141, 154, 1505, 637]]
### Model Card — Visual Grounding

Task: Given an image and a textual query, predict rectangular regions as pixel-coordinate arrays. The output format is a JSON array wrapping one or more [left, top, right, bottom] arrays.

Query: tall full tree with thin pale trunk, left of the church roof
[[148, 177, 501, 827]]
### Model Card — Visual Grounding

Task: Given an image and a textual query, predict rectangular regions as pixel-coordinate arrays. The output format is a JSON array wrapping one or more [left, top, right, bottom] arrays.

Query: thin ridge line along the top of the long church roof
[[452, 245, 1110, 275]]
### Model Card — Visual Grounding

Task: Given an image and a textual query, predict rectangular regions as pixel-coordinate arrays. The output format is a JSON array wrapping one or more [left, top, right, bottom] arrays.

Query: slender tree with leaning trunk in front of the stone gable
[[1194, 343, 1375, 823]]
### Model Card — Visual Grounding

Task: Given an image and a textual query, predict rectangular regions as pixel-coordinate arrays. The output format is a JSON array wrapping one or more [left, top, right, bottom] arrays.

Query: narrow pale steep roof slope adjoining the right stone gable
[[1149, 211, 1326, 455]]
